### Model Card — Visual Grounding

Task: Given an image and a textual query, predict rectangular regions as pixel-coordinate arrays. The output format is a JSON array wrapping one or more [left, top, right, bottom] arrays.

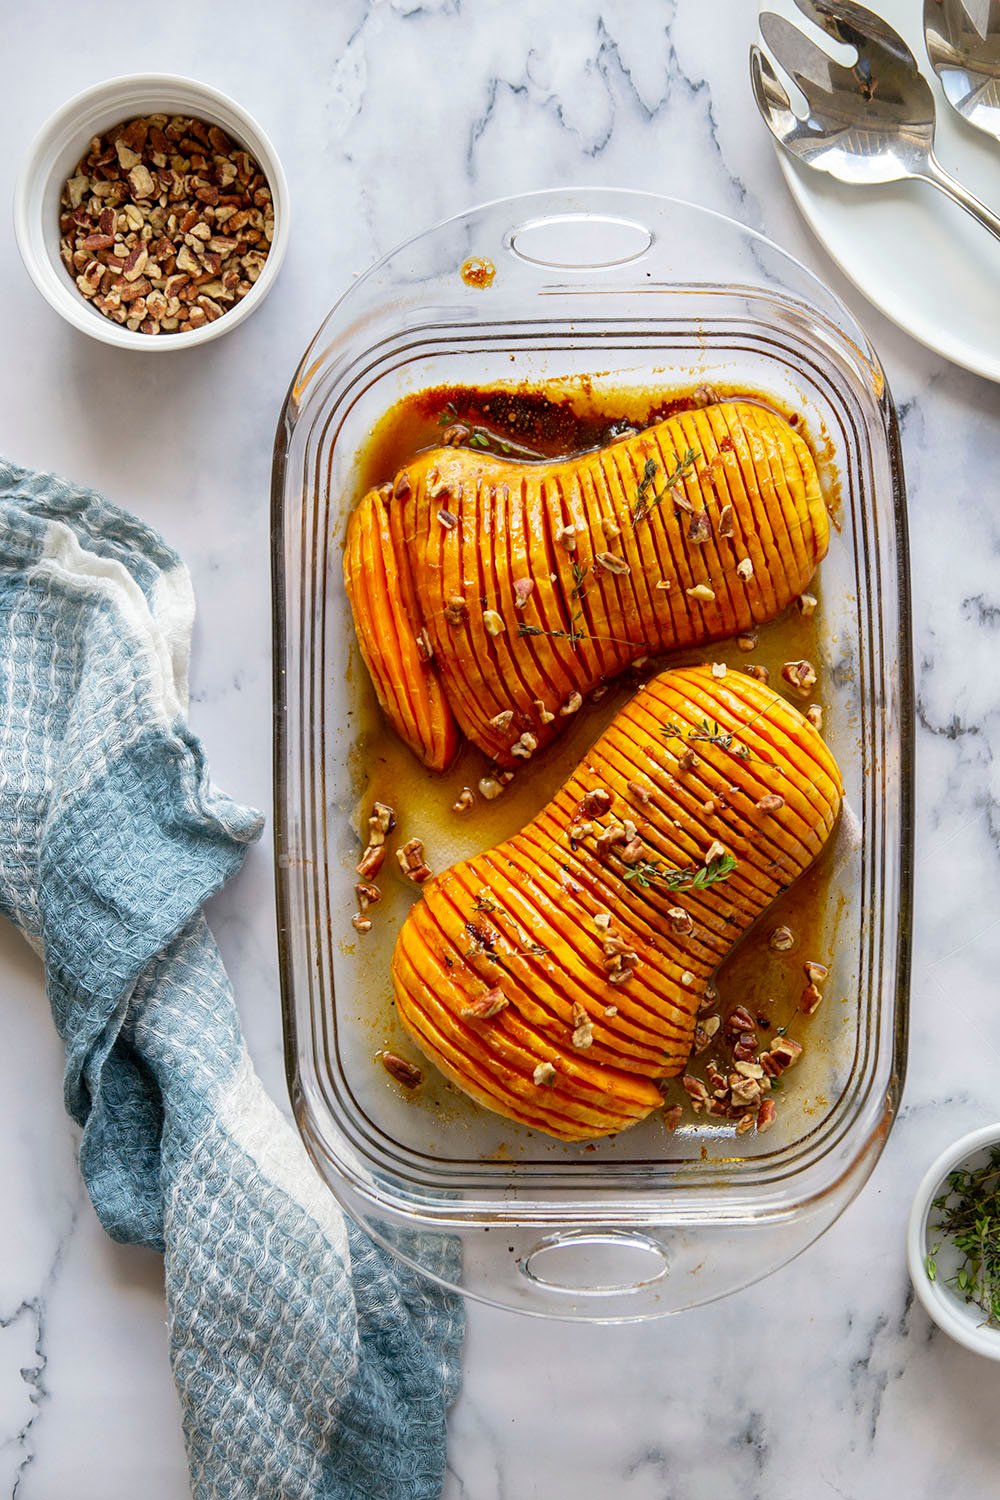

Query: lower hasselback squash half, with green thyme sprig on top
[[393, 666, 843, 1140]]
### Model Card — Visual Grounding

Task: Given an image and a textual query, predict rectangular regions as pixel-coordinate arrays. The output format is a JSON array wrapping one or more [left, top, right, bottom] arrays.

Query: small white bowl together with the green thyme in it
[[907, 1124, 1000, 1359]]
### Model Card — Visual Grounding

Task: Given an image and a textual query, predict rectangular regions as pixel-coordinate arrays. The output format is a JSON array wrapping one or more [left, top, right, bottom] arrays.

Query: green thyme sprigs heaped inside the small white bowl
[[925, 1146, 1000, 1328]]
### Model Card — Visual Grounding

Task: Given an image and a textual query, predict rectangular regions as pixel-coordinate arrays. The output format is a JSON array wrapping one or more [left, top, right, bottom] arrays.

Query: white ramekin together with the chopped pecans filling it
[[13, 75, 288, 350]]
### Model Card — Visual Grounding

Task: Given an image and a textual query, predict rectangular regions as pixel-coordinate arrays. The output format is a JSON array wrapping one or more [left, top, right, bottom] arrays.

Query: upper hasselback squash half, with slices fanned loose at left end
[[345, 401, 829, 771]]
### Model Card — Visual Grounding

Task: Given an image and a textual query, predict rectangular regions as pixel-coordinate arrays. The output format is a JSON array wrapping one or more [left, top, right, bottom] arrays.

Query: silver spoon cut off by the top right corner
[[924, 0, 1000, 141]]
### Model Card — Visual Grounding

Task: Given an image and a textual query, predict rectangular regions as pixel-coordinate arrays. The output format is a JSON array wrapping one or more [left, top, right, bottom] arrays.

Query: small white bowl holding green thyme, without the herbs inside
[[906, 1124, 1000, 1359]]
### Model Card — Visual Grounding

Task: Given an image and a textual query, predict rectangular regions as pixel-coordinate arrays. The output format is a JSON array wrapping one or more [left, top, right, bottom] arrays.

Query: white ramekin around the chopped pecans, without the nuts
[[13, 74, 288, 353]]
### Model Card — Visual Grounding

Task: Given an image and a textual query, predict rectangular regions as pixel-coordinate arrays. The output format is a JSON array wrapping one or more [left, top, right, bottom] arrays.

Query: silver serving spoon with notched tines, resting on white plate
[[750, 0, 1000, 239]]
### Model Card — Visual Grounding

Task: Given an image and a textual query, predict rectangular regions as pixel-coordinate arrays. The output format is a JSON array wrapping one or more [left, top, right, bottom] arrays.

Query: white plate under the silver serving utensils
[[760, 0, 1000, 381]]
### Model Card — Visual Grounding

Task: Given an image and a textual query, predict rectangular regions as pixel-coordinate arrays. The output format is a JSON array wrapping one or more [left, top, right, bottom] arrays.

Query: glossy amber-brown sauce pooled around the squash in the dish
[[342, 380, 847, 1154]]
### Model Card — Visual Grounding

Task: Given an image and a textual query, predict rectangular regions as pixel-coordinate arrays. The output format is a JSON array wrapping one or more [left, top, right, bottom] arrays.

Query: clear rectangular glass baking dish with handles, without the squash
[[273, 189, 913, 1320]]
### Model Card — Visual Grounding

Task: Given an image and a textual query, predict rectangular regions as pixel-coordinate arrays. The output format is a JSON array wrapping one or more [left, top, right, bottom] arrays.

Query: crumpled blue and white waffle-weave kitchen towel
[[0, 464, 462, 1500]]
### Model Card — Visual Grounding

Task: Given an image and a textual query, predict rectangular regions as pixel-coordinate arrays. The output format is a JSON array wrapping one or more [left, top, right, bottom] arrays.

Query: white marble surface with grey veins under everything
[[0, 0, 1000, 1500]]
